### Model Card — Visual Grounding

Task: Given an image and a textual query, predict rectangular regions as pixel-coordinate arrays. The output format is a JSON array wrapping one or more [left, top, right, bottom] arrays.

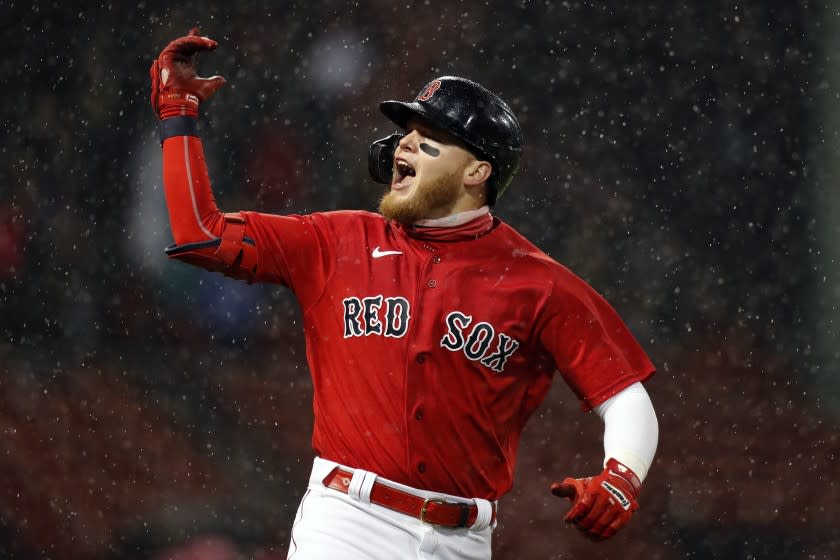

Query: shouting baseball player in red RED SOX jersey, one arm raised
[[150, 30, 658, 560]]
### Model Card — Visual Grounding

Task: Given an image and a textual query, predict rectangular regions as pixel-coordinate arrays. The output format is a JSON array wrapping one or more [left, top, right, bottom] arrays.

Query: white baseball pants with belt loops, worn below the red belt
[[287, 458, 495, 560]]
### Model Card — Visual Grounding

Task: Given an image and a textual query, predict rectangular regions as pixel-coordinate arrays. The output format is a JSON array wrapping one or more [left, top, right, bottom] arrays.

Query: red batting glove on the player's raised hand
[[149, 28, 225, 120]]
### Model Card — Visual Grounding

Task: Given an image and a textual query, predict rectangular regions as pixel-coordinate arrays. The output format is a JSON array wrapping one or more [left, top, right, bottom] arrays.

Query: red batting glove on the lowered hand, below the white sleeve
[[551, 459, 642, 541]]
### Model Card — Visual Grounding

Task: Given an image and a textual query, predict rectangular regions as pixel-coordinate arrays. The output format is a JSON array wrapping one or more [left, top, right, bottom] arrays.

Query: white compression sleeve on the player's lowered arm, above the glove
[[595, 383, 659, 480]]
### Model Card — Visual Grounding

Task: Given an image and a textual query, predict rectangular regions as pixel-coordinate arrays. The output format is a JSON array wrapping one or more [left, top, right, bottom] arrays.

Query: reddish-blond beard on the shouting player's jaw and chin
[[379, 174, 461, 225]]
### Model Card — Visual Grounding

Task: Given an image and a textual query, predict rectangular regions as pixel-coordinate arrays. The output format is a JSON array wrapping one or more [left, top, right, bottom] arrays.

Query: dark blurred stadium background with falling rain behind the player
[[0, 0, 840, 560]]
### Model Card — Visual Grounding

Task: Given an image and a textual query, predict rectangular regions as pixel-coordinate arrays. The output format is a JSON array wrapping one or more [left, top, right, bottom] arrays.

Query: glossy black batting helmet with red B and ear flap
[[368, 76, 522, 206]]
